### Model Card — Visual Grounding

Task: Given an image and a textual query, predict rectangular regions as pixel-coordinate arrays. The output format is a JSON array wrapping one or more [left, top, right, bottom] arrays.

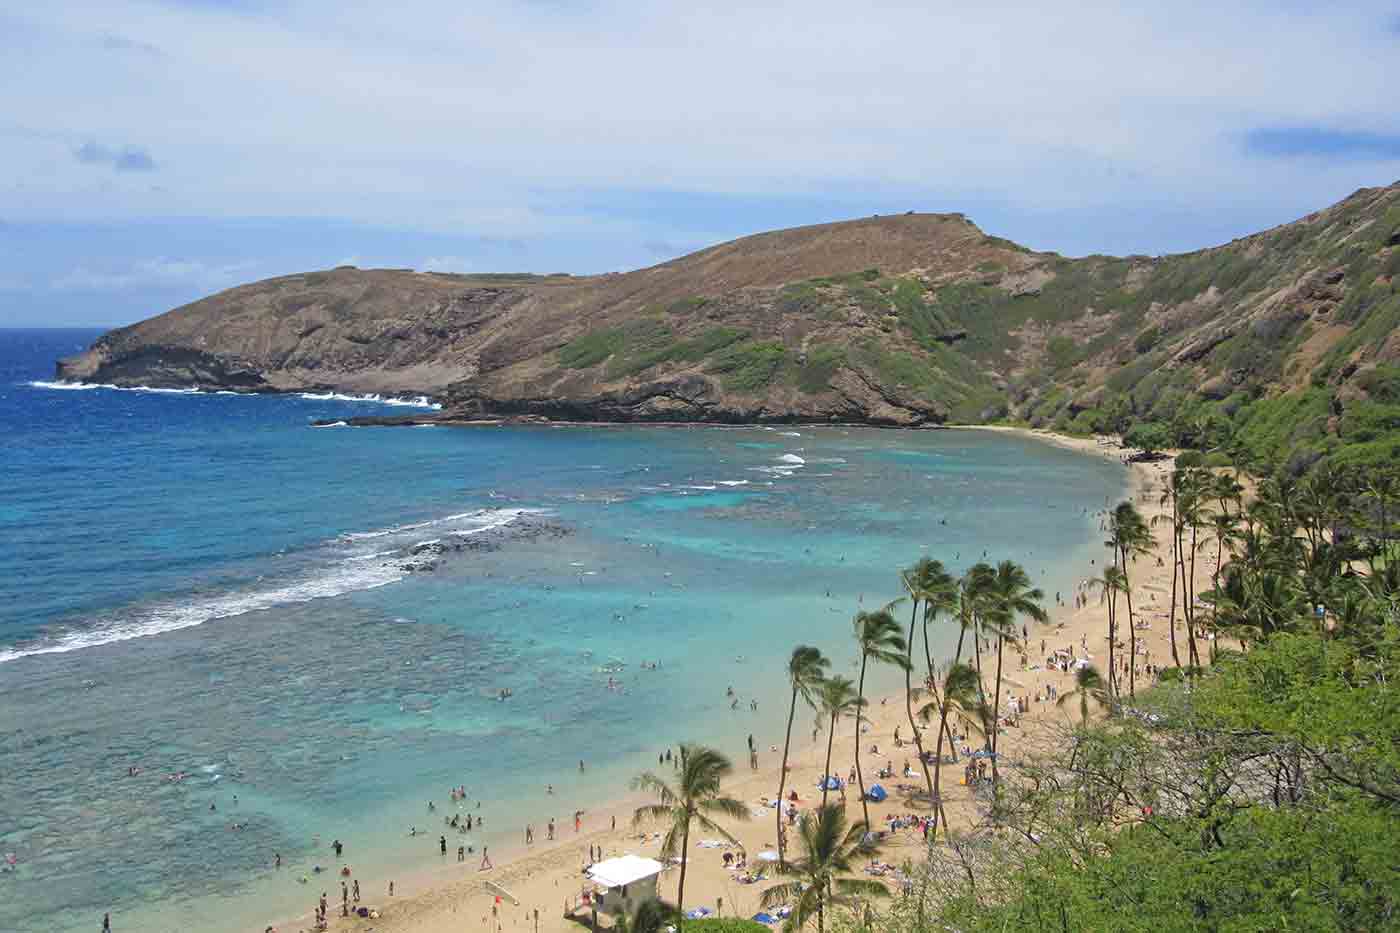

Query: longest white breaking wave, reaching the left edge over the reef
[[0, 509, 543, 664]]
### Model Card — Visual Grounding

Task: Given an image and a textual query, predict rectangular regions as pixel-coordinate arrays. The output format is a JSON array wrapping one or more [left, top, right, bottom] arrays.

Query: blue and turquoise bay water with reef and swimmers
[[0, 332, 1126, 933]]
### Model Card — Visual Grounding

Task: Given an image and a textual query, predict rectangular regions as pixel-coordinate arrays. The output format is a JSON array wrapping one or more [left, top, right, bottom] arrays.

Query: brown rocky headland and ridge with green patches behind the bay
[[57, 185, 1400, 429]]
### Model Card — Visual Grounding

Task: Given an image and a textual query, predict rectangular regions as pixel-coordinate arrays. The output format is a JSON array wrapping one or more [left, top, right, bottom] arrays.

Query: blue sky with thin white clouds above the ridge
[[0, 0, 1400, 326]]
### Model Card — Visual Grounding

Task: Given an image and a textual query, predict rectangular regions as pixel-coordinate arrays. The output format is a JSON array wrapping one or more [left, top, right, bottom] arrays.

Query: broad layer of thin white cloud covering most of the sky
[[0, 0, 1400, 250]]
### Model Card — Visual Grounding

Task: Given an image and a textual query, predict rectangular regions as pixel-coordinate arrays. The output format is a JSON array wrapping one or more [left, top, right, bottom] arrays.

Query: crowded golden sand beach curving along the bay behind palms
[[289, 427, 1214, 933]]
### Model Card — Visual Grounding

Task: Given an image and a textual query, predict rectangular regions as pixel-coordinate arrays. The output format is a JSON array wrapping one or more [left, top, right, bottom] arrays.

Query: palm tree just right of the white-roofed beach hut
[[631, 744, 749, 933]]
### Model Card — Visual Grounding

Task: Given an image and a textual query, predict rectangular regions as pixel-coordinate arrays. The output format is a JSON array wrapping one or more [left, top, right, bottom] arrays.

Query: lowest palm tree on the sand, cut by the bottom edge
[[760, 804, 889, 933]]
